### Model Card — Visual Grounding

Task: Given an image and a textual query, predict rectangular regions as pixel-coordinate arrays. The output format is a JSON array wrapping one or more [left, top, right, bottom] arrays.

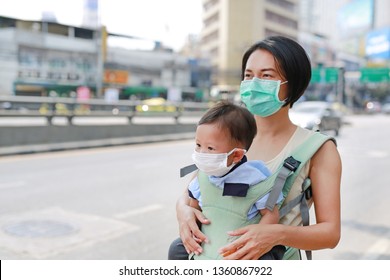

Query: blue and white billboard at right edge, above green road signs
[[366, 27, 390, 59]]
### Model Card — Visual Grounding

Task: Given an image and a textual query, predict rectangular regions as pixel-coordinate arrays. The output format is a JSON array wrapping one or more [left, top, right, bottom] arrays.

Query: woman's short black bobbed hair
[[241, 36, 311, 107]]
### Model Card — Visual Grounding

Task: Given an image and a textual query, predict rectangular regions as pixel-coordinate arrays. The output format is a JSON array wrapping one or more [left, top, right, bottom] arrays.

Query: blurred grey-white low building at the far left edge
[[0, 17, 98, 98]]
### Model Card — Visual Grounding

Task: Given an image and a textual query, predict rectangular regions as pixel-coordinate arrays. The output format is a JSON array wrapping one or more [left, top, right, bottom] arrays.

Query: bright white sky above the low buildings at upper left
[[0, 0, 202, 50]]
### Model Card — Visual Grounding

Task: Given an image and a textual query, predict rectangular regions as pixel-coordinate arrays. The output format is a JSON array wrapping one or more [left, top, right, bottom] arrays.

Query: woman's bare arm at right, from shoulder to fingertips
[[220, 141, 341, 259]]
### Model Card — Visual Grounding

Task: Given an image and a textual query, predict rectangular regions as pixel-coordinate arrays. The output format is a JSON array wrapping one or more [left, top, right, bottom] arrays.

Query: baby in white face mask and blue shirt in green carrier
[[184, 101, 285, 259]]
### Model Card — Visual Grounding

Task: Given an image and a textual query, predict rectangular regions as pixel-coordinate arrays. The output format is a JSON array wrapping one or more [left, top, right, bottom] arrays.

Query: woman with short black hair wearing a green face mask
[[168, 36, 341, 260]]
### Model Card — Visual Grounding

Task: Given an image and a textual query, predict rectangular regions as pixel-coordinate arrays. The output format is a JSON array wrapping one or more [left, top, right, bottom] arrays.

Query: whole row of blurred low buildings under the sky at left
[[0, 17, 210, 100]]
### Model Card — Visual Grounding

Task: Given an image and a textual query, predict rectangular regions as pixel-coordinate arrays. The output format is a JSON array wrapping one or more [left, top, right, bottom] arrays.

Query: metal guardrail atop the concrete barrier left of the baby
[[0, 96, 210, 124]]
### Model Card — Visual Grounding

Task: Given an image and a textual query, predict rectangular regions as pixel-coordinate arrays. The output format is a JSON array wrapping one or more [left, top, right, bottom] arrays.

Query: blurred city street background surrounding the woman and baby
[[0, 0, 390, 259]]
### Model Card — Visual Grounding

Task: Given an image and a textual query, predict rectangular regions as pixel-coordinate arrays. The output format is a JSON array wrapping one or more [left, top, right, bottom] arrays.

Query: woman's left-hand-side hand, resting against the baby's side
[[177, 204, 210, 255]]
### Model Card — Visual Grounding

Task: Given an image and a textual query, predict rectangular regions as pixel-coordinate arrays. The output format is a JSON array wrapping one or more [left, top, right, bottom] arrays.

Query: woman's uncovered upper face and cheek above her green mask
[[244, 49, 287, 100]]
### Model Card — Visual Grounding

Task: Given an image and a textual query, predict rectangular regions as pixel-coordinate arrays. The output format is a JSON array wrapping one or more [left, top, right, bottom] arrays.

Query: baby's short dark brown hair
[[198, 100, 257, 150]]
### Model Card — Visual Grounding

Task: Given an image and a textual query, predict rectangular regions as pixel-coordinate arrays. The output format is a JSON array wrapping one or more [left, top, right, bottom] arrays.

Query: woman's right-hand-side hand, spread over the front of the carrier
[[219, 224, 279, 260]]
